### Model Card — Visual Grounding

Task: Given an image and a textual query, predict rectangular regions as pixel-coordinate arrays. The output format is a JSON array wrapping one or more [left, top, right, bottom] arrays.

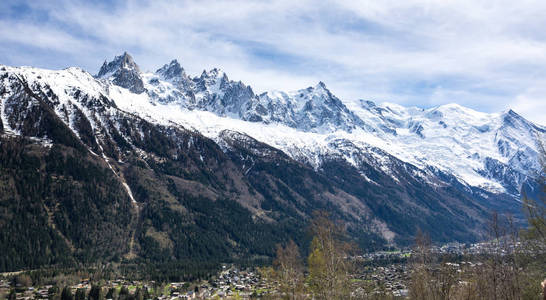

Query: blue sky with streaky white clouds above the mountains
[[0, 0, 546, 125]]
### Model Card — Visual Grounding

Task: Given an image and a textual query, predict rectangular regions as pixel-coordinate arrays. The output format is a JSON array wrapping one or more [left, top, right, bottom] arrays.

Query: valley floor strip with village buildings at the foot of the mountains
[[4, 243, 540, 299]]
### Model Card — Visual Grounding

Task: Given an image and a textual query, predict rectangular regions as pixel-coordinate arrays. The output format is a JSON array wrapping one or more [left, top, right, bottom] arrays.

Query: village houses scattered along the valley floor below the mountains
[[0, 243, 506, 300]]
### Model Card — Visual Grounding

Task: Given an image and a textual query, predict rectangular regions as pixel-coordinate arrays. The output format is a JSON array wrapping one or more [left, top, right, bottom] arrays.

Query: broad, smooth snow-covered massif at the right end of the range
[[344, 100, 544, 192]]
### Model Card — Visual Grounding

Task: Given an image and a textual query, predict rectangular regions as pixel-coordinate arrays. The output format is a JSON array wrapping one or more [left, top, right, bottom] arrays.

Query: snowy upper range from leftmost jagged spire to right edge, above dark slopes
[[87, 53, 546, 199]]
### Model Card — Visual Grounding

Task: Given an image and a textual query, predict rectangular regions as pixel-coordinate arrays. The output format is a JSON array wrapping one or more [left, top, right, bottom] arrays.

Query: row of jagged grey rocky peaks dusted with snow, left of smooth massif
[[92, 52, 366, 132]]
